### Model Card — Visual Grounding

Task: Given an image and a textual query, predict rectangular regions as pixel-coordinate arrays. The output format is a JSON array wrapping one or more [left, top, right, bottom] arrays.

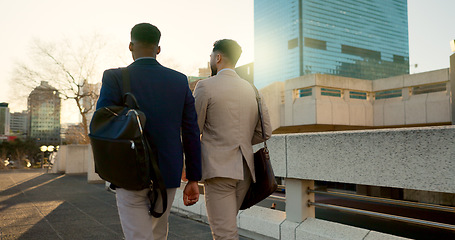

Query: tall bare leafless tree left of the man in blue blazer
[[13, 35, 120, 143]]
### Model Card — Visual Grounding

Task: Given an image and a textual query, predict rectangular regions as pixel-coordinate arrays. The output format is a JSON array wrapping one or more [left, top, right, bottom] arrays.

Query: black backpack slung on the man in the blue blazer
[[89, 68, 167, 218]]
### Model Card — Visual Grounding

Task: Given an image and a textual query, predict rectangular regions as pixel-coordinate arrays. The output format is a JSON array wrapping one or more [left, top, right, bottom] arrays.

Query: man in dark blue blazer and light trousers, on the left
[[96, 23, 201, 240]]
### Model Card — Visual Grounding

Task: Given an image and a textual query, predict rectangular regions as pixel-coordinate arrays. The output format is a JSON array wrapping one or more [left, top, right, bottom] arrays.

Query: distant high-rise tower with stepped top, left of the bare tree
[[28, 81, 61, 145]]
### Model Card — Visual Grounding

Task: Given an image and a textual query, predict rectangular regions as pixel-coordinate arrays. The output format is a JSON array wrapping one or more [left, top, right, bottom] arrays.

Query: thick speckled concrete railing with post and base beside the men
[[173, 126, 455, 239]]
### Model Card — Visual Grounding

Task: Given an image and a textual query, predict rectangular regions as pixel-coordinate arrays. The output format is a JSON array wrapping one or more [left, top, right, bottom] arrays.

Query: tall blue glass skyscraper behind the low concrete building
[[254, 0, 409, 88]]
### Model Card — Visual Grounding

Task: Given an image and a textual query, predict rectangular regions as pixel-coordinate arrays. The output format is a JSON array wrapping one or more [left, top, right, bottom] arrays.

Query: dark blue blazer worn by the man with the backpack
[[96, 58, 201, 188]]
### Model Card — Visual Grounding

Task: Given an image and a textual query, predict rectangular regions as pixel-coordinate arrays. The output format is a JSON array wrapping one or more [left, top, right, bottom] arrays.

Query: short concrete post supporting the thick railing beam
[[286, 178, 315, 223]]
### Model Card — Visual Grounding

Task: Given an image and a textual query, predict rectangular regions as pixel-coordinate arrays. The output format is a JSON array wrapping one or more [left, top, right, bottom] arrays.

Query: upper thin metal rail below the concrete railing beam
[[307, 189, 455, 213]]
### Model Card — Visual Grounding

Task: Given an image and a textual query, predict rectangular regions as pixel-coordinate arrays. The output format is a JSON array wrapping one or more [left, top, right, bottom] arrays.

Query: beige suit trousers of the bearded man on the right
[[204, 161, 251, 240]]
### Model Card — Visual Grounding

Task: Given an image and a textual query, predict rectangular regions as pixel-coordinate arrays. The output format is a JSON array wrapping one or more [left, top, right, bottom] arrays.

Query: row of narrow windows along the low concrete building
[[296, 83, 447, 100]]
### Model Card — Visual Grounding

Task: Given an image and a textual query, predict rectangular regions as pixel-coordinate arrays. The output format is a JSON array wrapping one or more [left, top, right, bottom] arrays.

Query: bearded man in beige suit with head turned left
[[194, 39, 272, 239]]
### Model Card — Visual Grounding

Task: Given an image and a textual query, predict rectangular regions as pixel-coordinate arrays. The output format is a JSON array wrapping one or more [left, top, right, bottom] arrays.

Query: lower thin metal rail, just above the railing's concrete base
[[308, 201, 455, 231]]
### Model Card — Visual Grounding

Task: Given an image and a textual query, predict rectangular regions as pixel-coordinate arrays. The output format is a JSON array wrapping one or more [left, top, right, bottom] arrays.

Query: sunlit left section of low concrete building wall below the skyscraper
[[282, 74, 373, 126]]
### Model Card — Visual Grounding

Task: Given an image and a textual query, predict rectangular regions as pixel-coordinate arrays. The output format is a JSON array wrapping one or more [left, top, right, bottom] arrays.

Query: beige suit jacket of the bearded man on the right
[[194, 70, 272, 181]]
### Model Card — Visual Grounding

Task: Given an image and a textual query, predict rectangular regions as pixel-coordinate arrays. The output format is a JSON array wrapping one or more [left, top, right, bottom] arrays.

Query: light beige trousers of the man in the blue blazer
[[116, 188, 177, 240]]
